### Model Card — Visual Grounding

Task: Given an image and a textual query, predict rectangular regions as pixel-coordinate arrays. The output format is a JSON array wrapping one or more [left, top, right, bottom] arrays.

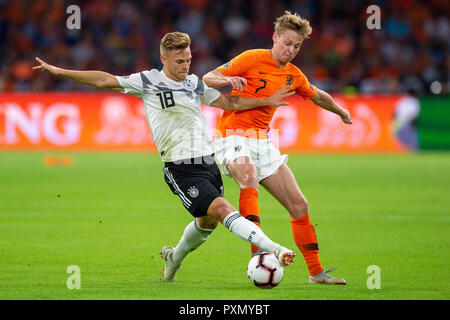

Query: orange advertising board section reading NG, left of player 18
[[0, 93, 156, 151]]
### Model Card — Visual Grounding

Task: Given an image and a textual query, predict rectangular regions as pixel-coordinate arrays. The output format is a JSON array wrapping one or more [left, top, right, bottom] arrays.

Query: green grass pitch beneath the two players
[[0, 153, 450, 300]]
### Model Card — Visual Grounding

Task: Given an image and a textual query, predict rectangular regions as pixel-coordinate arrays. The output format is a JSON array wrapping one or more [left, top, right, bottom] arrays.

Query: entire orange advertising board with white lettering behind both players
[[0, 93, 408, 152]]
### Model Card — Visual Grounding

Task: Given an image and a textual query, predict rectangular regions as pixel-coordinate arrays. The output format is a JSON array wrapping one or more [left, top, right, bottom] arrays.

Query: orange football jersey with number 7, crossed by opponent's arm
[[217, 49, 317, 138]]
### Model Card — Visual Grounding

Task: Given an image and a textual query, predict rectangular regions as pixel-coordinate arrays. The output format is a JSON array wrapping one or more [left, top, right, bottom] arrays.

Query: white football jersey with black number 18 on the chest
[[116, 69, 220, 162]]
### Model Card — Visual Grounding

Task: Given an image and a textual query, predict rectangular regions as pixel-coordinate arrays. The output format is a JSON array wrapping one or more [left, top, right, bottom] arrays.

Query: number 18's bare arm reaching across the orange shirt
[[211, 86, 295, 110]]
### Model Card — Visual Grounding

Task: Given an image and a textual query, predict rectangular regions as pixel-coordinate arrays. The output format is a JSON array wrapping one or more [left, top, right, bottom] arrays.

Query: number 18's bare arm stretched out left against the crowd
[[33, 57, 124, 92]]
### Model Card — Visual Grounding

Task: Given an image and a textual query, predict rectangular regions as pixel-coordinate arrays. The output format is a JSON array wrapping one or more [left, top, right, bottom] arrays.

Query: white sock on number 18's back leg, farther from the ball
[[172, 219, 214, 263]]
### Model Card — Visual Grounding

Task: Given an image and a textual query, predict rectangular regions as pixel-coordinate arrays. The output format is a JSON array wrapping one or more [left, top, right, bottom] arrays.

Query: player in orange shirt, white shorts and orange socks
[[203, 11, 352, 284]]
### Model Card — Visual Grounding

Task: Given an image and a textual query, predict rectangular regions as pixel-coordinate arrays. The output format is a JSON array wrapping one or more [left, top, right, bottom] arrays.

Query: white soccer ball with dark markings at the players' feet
[[247, 252, 284, 289]]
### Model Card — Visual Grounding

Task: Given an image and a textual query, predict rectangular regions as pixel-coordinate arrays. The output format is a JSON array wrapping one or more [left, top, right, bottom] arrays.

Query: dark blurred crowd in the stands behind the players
[[0, 0, 450, 95]]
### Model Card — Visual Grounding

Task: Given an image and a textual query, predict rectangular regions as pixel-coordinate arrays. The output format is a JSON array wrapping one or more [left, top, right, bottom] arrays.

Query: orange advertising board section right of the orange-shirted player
[[272, 96, 407, 152]]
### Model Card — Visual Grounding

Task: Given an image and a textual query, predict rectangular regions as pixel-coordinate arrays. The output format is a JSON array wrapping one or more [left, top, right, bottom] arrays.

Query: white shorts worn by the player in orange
[[214, 136, 288, 182]]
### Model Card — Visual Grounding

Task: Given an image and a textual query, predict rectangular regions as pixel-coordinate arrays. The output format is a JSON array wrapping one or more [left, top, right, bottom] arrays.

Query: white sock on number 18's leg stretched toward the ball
[[223, 211, 280, 253]]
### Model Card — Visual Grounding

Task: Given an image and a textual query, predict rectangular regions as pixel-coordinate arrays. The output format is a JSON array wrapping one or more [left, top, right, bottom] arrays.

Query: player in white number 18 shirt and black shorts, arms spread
[[33, 32, 295, 281]]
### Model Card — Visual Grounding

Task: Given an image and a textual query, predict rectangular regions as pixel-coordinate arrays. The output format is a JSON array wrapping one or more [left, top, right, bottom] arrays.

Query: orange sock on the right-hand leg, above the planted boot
[[291, 214, 323, 276]]
